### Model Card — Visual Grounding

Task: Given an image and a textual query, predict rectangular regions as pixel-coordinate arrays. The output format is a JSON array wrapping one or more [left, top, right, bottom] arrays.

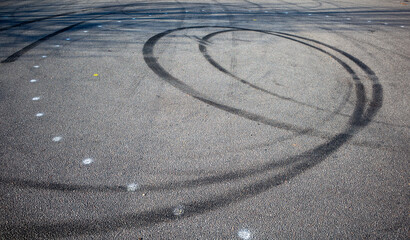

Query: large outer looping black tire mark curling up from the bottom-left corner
[[0, 26, 383, 238]]
